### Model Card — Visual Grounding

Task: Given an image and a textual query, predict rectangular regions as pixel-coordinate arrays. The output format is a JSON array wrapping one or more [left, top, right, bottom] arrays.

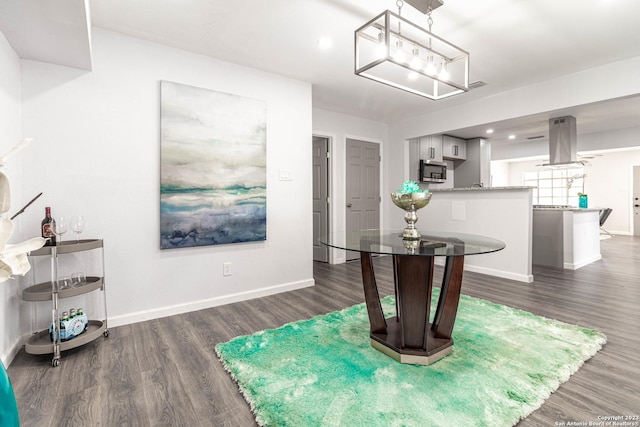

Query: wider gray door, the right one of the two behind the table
[[346, 139, 380, 260]]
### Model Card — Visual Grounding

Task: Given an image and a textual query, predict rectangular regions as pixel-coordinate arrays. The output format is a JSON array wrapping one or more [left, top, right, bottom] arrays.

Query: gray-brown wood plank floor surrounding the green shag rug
[[8, 236, 640, 427]]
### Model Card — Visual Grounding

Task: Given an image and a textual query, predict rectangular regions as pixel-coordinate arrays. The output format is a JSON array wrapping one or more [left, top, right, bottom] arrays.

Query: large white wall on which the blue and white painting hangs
[[13, 28, 313, 354]]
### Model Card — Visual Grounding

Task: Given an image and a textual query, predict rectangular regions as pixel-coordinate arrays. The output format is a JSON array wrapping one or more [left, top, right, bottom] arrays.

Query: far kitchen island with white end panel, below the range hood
[[533, 206, 602, 270]]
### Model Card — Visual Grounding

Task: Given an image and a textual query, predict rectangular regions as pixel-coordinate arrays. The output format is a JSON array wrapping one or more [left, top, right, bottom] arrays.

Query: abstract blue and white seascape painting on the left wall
[[160, 81, 267, 249]]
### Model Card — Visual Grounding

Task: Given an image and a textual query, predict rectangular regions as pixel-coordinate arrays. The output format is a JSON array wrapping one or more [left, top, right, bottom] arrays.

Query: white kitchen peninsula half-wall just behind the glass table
[[416, 186, 533, 283]]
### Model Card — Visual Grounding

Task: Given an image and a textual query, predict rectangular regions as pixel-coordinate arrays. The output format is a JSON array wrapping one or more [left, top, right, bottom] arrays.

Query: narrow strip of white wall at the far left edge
[[0, 32, 25, 365]]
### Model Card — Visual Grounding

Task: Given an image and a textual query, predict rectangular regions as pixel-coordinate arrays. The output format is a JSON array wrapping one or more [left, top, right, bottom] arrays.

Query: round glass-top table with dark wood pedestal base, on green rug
[[320, 230, 505, 365]]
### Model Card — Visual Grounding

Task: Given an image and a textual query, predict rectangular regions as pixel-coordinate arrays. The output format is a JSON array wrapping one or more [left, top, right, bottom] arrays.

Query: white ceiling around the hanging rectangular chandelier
[[0, 0, 640, 144]]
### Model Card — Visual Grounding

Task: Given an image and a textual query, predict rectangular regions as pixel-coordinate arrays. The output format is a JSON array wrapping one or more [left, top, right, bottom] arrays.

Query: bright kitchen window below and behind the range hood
[[522, 168, 586, 206]]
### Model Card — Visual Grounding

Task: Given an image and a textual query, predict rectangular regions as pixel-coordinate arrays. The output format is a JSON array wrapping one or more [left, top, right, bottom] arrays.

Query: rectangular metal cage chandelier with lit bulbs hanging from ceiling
[[355, 3, 469, 100]]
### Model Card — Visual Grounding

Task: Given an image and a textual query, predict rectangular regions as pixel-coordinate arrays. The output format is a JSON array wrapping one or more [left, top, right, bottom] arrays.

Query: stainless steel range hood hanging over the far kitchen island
[[543, 116, 588, 168]]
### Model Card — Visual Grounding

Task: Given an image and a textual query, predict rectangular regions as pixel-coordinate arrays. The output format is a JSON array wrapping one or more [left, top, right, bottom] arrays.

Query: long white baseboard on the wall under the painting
[[108, 279, 315, 327]]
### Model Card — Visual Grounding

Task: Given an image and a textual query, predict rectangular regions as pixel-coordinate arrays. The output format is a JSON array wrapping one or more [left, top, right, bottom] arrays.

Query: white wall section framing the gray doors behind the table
[[313, 108, 391, 263]]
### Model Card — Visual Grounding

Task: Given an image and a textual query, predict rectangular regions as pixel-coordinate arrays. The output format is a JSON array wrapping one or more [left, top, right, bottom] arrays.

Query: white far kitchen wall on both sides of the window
[[498, 147, 640, 234]]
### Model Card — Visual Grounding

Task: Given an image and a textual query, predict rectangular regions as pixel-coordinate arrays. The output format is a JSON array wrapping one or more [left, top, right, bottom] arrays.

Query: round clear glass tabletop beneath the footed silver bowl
[[318, 230, 506, 256]]
